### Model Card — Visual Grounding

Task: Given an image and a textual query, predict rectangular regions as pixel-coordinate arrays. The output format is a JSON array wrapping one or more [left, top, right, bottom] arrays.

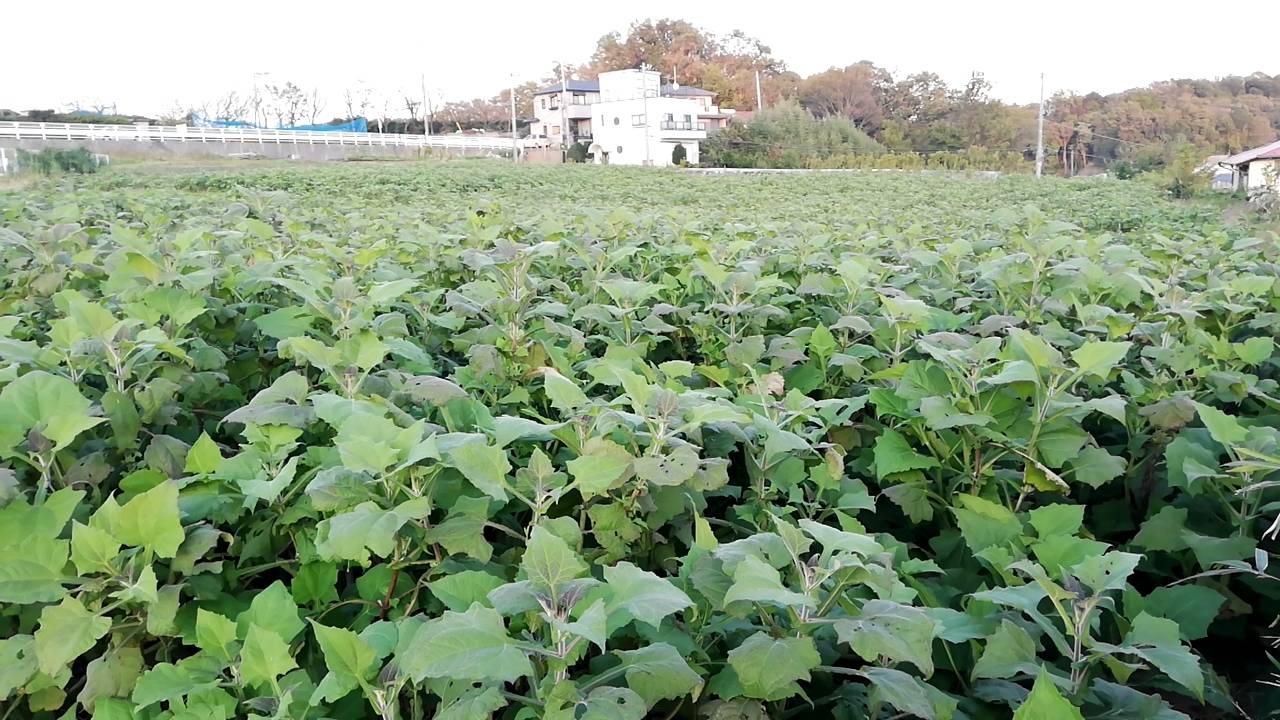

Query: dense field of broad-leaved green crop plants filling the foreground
[[0, 161, 1280, 720]]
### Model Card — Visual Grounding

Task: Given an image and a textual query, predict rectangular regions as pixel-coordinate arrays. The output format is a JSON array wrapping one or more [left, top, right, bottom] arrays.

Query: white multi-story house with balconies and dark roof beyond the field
[[529, 70, 733, 165]]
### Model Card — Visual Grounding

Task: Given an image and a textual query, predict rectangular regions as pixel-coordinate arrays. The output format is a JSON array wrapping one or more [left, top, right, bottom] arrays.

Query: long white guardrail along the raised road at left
[[0, 122, 522, 150]]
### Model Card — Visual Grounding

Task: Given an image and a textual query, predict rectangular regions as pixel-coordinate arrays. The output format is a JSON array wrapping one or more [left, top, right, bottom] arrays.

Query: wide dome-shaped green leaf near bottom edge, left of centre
[[397, 605, 532, 683]]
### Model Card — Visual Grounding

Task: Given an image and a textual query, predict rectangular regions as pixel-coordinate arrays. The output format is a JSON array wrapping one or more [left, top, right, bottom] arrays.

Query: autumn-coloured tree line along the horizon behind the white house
[[12, 19, 1280, 174]]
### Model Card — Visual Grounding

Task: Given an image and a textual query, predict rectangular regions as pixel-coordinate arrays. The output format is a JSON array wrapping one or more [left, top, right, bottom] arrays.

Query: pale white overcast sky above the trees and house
[[10, 0, 1280, 118]]
